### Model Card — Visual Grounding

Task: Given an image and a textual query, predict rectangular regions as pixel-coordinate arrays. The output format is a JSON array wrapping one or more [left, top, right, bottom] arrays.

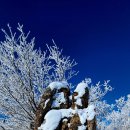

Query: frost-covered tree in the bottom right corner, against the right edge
[[105, 95, 130, 130]]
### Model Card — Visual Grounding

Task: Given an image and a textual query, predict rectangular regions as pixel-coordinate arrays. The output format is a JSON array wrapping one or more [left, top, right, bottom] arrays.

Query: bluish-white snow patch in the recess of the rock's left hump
[[51, 92, 66, 108]]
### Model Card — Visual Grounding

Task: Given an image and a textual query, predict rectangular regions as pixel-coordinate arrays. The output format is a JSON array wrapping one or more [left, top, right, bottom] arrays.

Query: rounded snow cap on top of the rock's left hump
[[48, 81, 69, 90]]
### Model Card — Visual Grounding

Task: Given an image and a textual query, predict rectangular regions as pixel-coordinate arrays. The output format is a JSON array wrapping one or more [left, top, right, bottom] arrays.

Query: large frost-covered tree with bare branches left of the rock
[[0, 24, 77, 130]]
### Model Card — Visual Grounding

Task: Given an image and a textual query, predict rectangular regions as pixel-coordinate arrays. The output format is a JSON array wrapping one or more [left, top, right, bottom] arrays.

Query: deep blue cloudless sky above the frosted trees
[[0, 0, 130, 102]]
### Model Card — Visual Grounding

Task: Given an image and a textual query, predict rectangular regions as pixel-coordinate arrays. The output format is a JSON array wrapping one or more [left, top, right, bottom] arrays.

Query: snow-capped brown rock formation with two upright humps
[[34, 82, 96, 130]]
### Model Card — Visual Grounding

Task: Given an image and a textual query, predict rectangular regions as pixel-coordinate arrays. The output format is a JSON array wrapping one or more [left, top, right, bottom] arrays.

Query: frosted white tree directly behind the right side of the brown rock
[[83, 78, 113, 130]]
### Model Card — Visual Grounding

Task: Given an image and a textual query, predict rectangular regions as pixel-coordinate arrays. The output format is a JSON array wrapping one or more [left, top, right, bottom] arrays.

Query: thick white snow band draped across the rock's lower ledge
[[38, 105, 95, 130]]
